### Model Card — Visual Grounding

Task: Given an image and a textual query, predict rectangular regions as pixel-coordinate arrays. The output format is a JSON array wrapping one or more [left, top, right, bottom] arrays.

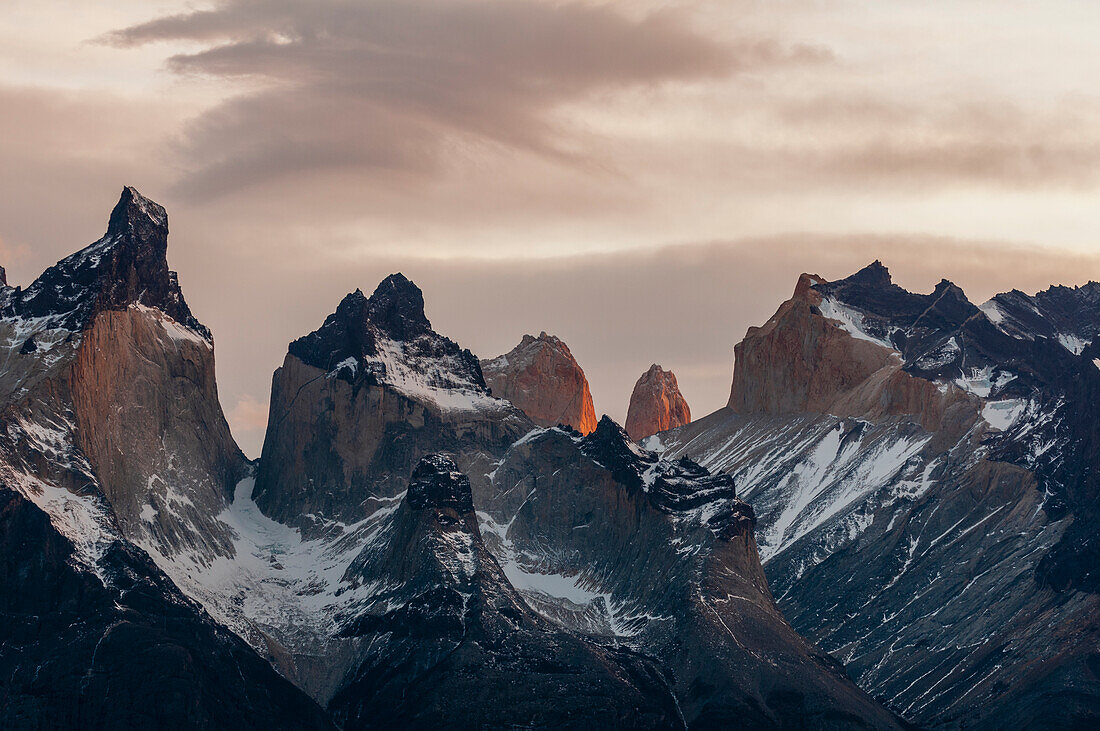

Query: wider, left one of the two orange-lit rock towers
[[482, 332, 596, 434]]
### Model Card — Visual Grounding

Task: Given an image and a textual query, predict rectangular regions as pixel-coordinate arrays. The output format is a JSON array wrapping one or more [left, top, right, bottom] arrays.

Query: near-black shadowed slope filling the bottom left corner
[[0, 488, 332, 729]]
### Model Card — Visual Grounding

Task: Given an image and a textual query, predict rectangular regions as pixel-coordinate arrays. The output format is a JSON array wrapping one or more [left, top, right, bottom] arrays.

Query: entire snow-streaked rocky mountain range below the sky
[[0, 188, 1100, 729]]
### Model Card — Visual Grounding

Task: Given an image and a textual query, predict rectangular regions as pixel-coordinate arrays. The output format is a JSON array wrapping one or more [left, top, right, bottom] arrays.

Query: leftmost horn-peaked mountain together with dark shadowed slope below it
[[0, 188, 329, 728]]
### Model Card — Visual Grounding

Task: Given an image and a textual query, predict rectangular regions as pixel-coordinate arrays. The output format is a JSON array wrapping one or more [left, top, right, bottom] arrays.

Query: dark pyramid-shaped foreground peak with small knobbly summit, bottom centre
[[329, 455, 681, 729]]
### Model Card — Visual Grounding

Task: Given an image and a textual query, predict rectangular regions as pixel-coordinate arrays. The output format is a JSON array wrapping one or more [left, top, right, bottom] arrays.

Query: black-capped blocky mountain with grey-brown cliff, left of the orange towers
[[255, 274, 530, 530]]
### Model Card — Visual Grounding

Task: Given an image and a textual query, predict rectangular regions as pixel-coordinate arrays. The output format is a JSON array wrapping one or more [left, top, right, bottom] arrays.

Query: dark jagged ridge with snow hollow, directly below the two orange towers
[[482, 418, 897, 728]]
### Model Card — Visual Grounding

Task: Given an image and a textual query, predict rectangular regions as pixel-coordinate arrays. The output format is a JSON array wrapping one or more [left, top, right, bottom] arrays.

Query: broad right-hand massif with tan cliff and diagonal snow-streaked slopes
[[660, 263, 1100, 728]]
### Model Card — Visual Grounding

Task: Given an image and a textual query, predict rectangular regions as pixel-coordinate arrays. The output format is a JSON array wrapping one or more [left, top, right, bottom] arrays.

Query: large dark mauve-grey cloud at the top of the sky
[[107, 0, 831, 196]]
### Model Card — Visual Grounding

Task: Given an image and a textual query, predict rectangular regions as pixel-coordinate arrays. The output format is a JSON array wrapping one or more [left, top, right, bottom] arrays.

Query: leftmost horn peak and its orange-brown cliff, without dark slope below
[[0, 183, 246, 557]]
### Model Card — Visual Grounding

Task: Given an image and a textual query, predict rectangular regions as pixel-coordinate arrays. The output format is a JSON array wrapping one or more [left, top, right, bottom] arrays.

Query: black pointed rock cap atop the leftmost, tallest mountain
[[4, 187, 210, 340]]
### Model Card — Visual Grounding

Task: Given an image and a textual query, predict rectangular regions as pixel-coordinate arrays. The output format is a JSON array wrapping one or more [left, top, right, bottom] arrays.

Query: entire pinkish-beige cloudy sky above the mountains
[[0, 0, 1100, 454]]
